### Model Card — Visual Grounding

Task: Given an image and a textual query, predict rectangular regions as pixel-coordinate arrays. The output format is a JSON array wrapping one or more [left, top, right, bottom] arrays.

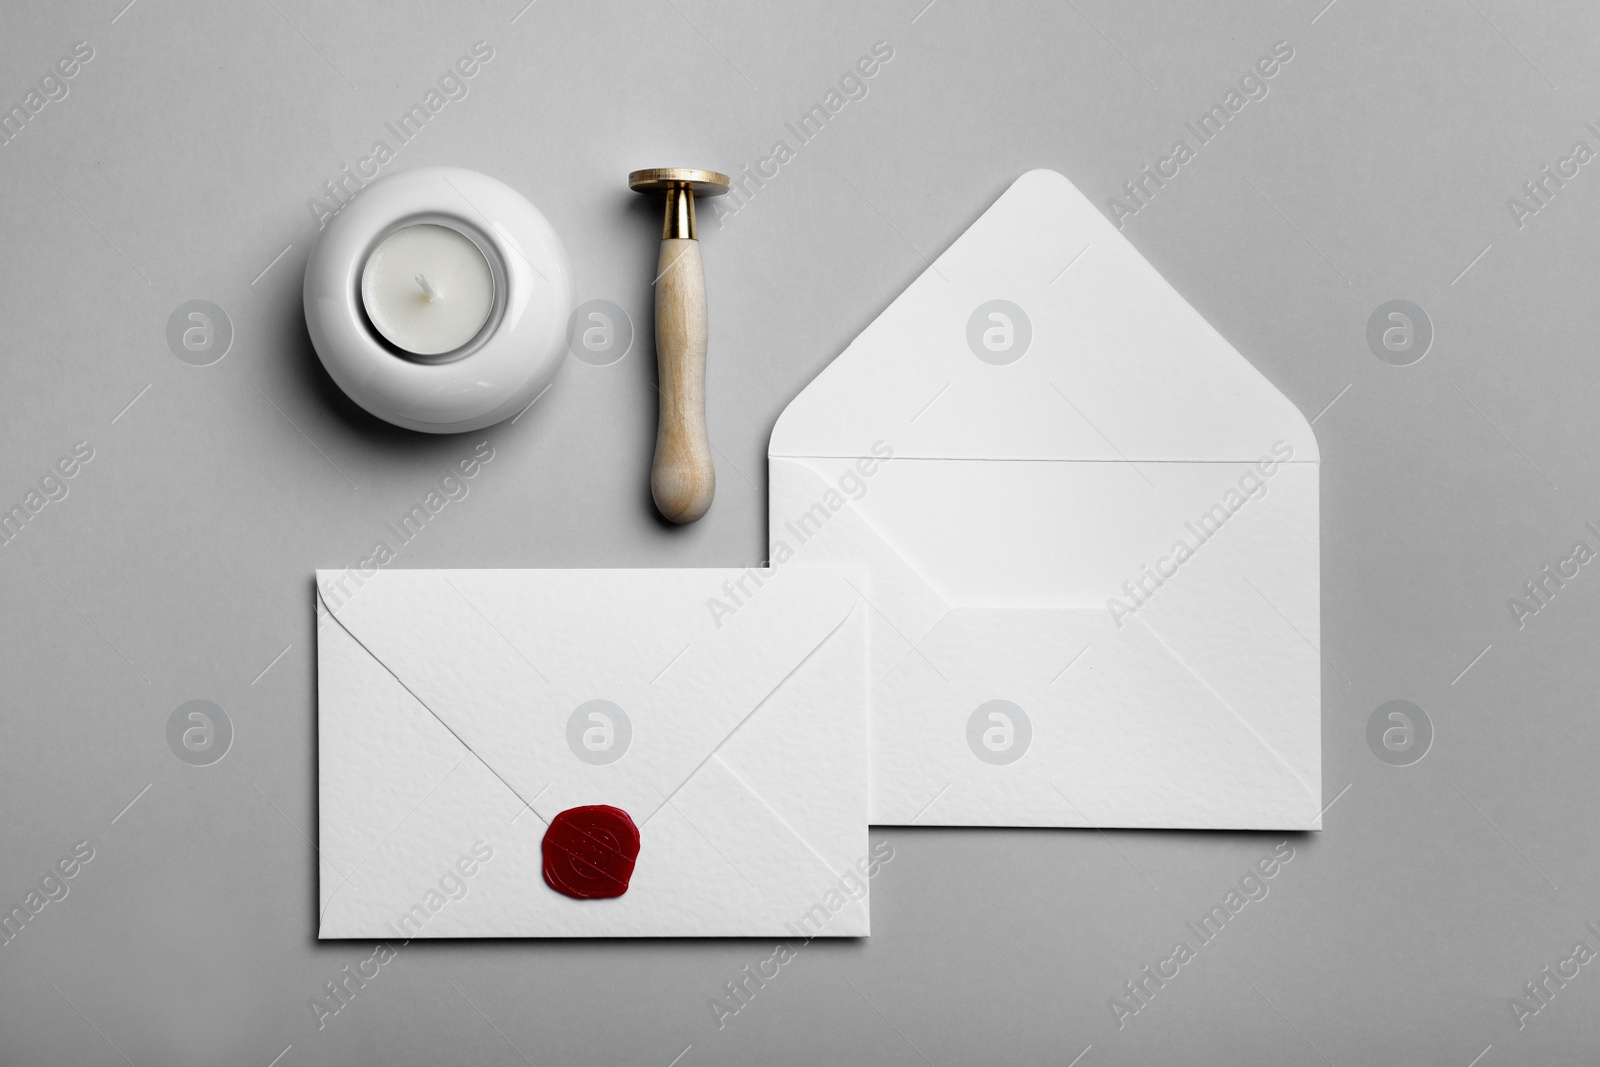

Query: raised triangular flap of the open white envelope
[[768, 170, 1317, 462]]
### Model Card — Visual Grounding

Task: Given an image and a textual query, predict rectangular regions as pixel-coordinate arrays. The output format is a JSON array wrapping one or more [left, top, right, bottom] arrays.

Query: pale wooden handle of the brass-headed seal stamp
[[650, 237, 717, 523]]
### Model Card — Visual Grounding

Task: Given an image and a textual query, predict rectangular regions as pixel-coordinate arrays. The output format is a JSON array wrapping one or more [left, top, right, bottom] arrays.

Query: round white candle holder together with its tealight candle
[[302, 166, 573, 434]]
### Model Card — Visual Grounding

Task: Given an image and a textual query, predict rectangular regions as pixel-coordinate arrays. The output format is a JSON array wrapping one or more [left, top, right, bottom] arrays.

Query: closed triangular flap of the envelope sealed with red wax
[[318, 569, 862, 822]]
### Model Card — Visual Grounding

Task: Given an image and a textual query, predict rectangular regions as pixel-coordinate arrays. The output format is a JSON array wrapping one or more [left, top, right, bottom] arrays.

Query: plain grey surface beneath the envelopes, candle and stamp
[[0, 0, 1600, 1067]]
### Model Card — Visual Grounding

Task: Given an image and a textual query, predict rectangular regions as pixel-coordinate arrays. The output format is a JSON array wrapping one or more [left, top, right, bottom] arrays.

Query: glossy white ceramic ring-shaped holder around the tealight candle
[[304, 166, 573, 434]]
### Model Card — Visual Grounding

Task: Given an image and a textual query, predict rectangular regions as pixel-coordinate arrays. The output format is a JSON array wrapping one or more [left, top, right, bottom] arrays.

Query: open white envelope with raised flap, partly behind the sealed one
[[768, 170, 1322, 829]]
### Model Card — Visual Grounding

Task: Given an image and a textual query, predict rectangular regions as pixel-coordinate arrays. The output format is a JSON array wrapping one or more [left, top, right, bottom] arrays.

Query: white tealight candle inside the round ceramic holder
[[362, 222, 494, 355]]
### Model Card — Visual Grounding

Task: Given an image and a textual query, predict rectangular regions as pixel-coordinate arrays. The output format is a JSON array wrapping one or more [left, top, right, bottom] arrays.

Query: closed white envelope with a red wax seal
[[317, 568, 877, 941]]
